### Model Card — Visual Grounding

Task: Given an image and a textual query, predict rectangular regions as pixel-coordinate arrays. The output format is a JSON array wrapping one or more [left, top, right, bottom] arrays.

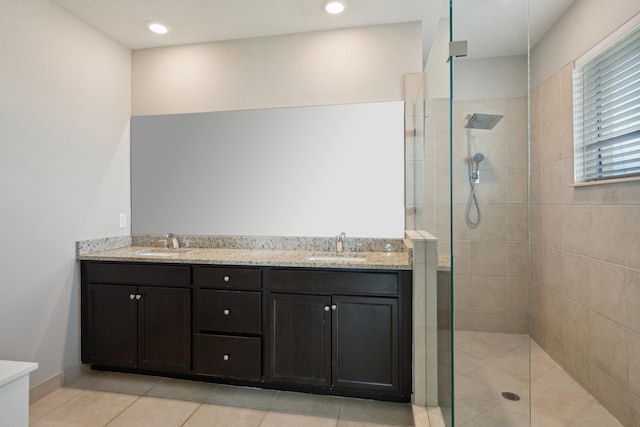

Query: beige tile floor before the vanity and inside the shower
[[30, 331, 621, 427]]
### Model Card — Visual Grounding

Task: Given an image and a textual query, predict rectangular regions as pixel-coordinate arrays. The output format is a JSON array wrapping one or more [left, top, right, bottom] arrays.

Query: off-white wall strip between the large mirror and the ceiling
[[132, 22, 422, 116]]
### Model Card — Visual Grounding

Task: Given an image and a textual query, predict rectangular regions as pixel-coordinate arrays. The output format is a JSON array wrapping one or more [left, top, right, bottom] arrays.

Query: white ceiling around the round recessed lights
[[52, 0, 575, 61]]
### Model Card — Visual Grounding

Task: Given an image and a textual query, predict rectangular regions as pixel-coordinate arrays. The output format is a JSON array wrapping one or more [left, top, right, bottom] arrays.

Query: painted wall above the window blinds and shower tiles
[[531, 0, 640, 88]]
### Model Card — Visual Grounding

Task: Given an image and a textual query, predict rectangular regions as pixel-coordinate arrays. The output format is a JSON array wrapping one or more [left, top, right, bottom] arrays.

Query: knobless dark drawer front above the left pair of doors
[[87, 262, 191, 286]]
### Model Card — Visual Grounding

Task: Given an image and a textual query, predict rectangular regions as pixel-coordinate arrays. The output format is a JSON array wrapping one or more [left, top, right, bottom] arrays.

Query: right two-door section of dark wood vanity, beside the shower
[[266, 269, 411, 400]]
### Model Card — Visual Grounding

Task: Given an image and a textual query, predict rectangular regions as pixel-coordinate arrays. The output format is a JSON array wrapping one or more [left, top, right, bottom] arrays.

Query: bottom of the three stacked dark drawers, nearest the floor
[[194, 334, 261, 381]]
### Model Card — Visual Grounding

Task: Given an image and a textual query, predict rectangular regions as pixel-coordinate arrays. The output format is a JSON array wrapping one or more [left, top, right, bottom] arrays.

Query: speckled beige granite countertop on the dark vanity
[[78, 246, 411, 270]]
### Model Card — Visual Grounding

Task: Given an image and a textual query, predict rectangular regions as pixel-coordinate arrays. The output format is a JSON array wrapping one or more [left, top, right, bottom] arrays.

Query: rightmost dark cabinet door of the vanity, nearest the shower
[[332, 296, 399, 391]]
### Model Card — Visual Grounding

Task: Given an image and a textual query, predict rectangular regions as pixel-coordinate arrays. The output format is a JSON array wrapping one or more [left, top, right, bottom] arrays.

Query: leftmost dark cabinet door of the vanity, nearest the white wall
[[88, 285, 138, 368]]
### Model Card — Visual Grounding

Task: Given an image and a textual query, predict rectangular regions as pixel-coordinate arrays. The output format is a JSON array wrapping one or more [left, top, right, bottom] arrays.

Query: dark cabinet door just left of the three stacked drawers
[[138, 286, 191, 373]]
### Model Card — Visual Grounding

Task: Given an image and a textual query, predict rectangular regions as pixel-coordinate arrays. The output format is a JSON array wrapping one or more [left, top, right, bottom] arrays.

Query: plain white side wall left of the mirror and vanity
[[0, 0, 131, 385]]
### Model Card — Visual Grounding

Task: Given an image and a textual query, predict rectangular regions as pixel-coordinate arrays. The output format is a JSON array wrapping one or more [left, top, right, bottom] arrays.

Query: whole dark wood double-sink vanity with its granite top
[[79, 247, 412, 401]]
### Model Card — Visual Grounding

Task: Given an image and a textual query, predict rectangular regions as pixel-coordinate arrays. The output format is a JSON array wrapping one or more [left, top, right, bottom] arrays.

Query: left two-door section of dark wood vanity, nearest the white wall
[[82, 263, 191, 373]]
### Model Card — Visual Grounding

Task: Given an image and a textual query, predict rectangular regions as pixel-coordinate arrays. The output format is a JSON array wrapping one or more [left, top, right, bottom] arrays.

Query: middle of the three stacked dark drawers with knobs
[[195, 289, 262, 334]]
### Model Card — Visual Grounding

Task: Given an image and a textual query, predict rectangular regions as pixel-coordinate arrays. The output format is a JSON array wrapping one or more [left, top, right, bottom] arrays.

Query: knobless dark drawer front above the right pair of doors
[[268, 269, 398, 296]]
